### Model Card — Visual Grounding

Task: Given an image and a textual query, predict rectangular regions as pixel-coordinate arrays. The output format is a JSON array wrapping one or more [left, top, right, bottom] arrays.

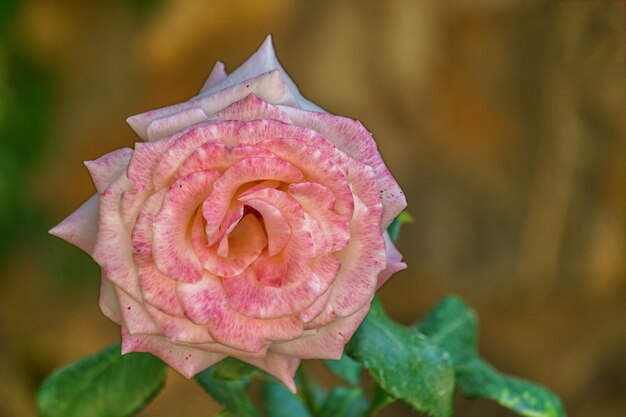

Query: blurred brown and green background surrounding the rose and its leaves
[[0, 0, 626, 417]]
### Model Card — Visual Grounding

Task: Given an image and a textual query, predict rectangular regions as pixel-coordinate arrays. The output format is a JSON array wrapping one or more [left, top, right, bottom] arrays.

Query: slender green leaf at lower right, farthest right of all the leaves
[[457, 358, 565, 417]]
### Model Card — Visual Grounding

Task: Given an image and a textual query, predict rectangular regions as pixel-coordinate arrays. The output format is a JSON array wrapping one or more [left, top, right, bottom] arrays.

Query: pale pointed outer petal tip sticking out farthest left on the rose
[[48, 194, 100, 255]]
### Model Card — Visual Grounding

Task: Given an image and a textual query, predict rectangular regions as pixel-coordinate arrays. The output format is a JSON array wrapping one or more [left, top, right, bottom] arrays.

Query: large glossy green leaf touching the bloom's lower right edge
[[347, 299, 454, 417]]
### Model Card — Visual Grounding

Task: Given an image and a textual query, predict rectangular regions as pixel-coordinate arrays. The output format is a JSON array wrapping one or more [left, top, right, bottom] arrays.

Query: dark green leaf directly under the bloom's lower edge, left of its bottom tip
[[195, 366, 260, 417]]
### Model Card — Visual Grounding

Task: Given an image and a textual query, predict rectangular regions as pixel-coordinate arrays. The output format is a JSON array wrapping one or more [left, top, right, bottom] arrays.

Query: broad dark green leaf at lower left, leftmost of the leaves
[[37, 343, 167, 417]]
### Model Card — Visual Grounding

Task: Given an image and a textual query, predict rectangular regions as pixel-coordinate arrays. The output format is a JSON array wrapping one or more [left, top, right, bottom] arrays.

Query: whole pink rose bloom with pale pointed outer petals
[[50, 36, 406, 391]]
